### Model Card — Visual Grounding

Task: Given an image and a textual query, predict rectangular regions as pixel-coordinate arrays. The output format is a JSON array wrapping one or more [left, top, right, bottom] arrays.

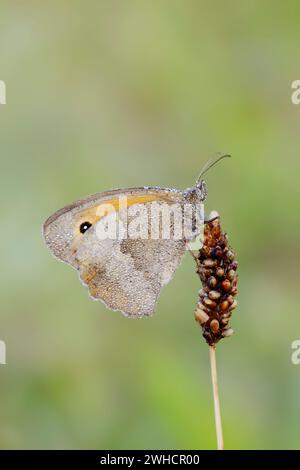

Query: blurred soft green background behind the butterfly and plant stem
[[0, 0, 300, 449]]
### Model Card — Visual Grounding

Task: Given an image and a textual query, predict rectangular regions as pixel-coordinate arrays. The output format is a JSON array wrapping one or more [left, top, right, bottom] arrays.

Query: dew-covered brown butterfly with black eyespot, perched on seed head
[[43, 155, 229, 318]]
